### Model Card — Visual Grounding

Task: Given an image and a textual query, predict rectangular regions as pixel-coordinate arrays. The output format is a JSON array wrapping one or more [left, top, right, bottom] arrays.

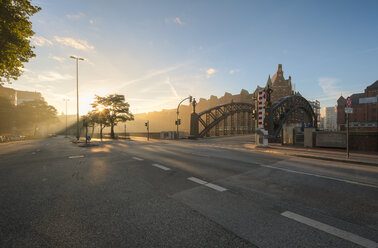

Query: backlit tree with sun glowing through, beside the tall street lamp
[[91, 94, 134, 138]]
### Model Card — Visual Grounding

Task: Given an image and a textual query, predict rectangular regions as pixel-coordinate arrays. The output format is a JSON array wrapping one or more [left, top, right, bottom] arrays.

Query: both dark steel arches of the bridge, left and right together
[[190, 95, 317, 140]]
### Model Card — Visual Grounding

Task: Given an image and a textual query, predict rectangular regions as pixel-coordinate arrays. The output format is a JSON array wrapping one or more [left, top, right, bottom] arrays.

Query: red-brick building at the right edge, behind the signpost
[[337, 80, 378, 131]]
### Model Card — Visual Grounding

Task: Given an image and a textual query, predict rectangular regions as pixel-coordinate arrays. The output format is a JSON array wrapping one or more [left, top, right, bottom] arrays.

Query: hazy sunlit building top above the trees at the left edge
[[0, 85, 43, 106]]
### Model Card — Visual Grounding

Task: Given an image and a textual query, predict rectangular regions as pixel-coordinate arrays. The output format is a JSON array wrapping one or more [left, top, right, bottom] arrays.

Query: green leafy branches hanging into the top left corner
[[0, 0, 41, 83]]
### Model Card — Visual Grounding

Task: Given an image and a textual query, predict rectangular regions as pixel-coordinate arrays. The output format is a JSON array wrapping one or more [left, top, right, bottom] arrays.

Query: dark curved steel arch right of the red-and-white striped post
[[267, 95, 317, 139]]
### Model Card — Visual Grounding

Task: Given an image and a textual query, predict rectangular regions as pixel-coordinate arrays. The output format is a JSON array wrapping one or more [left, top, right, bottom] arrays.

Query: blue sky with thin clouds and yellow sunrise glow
[[8, 0, 378, 114]]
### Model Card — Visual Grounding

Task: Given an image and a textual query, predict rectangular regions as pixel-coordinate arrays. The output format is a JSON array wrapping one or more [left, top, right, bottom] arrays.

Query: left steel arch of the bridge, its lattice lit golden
[[191, 102, 254, 137]]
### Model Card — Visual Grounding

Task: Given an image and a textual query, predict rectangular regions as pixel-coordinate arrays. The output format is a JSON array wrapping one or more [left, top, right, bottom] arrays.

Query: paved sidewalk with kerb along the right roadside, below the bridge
[[256, 144, 378, 166]]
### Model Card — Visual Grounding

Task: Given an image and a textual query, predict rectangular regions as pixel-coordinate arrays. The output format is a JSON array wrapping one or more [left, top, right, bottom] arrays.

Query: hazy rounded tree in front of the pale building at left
[[16, 100, 57, 136]]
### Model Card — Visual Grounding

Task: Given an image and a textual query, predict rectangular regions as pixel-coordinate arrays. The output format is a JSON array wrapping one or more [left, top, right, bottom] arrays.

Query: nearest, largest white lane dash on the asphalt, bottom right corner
[[281, 211, 378, 248]]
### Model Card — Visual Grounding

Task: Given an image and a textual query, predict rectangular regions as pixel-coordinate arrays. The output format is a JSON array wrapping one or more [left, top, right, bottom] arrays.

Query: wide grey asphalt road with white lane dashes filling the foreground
[[0, 136, 378, 248]]
